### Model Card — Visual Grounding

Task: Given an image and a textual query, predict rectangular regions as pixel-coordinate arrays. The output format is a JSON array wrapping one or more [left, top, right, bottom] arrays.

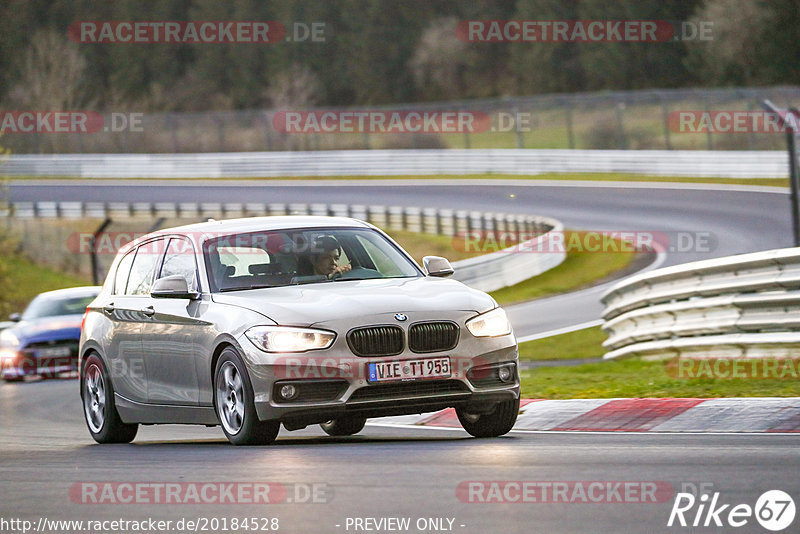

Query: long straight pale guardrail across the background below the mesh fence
[[0, 149, 789, 178]]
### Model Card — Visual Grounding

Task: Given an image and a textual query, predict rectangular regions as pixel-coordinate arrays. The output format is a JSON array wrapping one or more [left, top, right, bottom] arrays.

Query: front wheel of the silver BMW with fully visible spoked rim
[[214, 347, 281, 445]]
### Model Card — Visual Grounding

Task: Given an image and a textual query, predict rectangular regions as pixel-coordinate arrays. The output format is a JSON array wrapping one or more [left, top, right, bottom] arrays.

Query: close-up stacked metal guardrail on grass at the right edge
[[602, 248, 800, 359]]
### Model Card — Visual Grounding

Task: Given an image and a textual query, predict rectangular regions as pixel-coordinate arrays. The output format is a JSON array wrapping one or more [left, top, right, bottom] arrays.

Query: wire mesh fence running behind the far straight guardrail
[[3, 87, 800, 154]]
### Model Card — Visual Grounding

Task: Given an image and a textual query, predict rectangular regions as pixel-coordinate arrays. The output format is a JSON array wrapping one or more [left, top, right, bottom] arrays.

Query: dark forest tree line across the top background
[[0, 0, 800, 112]]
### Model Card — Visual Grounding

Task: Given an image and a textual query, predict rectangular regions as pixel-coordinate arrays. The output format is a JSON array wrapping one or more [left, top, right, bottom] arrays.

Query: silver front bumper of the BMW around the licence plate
[[242, 335, 520, 429]]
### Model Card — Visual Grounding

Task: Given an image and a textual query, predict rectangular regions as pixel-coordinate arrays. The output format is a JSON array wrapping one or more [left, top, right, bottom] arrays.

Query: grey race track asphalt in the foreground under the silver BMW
[[0, 380, 800, 534]]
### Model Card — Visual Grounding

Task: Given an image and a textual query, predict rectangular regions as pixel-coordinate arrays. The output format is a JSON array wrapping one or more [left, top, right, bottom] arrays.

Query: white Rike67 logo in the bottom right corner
[[667, 490, 796, 532]]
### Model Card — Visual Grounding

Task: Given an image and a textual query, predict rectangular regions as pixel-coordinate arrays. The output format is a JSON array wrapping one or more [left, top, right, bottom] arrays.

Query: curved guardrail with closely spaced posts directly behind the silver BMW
[[0, 202, 566, 291]]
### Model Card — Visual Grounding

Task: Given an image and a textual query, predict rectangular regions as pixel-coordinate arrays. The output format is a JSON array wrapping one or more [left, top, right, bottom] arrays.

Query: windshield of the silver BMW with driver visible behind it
[[203, 228, 422, 291]]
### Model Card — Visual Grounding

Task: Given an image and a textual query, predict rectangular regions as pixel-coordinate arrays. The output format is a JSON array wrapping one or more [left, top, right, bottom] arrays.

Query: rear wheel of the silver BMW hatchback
[[81, 354, 139, 443]]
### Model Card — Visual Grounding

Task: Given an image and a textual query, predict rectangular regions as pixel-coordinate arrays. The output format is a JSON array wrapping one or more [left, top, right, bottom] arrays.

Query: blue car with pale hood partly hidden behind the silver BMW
[[0, 286, 101, 382]]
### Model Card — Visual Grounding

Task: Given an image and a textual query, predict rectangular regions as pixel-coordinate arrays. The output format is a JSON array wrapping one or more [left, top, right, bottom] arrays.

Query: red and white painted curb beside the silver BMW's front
[[369, 397, 800, 433]]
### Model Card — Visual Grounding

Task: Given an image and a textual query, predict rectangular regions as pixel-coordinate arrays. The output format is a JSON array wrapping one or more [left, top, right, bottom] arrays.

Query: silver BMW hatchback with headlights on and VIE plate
[[79, 217, 520, 445]]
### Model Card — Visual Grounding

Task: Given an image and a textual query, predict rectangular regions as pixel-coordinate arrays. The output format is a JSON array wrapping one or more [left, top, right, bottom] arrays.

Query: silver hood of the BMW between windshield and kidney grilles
[[213, 277, 496, 326]]
